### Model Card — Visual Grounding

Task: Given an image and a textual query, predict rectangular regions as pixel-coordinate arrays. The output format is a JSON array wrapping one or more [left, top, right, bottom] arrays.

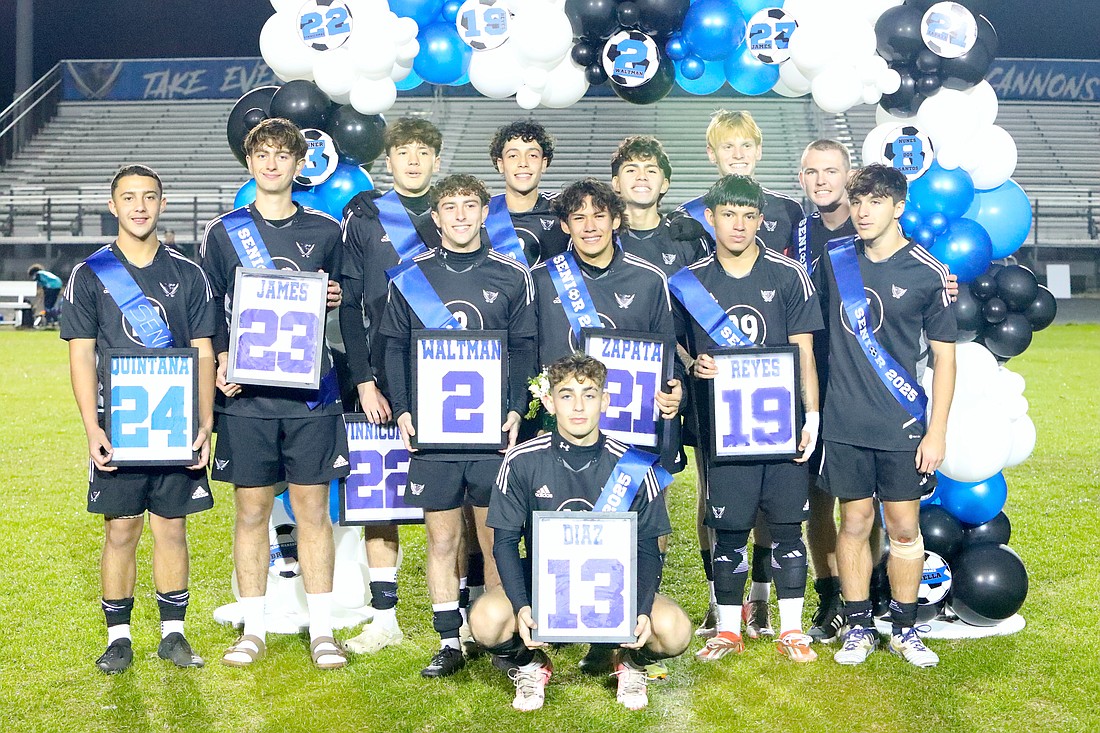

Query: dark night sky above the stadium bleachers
[[0, 0, 1100, 107]]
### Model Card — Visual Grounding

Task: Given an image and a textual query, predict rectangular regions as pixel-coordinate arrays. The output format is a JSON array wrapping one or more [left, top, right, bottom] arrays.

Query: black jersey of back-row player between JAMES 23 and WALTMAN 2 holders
[[340, 194, 440, 386]]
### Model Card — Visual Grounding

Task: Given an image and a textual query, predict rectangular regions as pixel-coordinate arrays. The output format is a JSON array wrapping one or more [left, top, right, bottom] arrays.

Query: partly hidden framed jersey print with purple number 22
[[340, 413, 424, 525]]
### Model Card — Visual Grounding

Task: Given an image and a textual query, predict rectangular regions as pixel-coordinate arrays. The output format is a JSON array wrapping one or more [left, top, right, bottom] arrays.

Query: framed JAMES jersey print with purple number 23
[[226, 267, 329, 390]]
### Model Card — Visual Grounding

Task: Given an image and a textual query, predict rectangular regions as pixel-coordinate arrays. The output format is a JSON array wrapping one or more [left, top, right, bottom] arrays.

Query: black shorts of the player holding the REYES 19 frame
[[704, 461, 810, 530]]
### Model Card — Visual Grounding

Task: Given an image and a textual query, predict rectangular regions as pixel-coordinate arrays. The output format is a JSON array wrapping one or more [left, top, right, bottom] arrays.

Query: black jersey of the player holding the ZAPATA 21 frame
[[531, 247, 675, 367]]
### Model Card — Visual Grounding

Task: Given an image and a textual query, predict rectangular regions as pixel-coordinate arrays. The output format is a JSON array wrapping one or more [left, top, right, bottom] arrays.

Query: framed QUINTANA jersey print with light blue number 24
[[103, 348, 199, 466]]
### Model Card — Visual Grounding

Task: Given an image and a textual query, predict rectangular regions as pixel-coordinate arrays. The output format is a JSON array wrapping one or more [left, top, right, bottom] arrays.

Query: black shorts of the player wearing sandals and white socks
[[210, 414, 351, 486]]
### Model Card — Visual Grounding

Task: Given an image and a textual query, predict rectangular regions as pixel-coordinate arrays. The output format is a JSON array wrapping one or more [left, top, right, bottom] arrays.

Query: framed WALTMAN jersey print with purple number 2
[[411, 329, 508, 452]]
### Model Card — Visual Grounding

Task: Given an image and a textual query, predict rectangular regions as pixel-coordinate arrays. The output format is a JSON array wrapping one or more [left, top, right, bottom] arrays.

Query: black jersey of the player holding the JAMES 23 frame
[[199, 205, 343, 418]]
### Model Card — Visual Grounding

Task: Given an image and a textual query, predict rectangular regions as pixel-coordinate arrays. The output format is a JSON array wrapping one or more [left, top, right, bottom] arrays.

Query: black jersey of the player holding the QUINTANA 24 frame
[[61, 244, 218, 409]]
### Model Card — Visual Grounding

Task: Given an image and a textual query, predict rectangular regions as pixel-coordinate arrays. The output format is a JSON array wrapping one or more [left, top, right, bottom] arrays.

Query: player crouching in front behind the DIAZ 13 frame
[[470, 352, 691, 711]]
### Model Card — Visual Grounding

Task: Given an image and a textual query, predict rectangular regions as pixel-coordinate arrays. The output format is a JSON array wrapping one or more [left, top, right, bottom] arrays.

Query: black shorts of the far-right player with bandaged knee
[[818, 440, 936, 502]]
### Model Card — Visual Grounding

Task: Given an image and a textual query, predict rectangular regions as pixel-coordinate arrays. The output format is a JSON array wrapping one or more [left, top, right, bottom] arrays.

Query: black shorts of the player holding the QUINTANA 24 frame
[[88, 466, 213, 519]]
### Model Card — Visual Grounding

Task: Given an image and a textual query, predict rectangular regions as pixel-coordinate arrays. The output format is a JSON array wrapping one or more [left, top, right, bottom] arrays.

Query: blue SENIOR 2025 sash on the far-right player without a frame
[[827, 237, 928, 422]]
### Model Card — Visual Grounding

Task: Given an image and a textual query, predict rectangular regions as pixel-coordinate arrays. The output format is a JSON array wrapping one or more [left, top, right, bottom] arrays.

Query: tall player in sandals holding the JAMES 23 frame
[[200, 118, 349, 669]]
